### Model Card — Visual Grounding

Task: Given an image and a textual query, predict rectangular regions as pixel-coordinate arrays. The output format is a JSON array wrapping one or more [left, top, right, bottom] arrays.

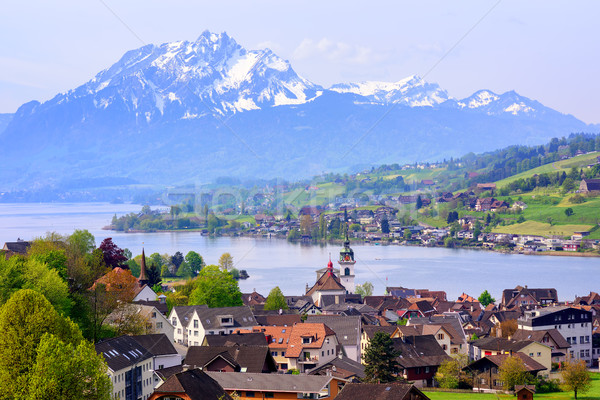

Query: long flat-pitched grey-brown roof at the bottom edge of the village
[[206, 371, 332, 393]]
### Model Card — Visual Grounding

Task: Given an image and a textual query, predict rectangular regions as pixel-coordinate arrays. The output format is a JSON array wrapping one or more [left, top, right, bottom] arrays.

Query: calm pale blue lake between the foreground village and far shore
[[0, 203, 600, 300]]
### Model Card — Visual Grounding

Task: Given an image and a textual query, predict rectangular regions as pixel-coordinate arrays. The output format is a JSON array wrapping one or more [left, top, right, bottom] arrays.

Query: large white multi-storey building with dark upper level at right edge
[[517, 306, 593, 365]]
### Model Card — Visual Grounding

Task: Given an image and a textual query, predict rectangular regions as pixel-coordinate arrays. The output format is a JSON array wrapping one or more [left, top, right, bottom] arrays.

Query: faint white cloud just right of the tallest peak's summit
[[292, 38, 381, 64]]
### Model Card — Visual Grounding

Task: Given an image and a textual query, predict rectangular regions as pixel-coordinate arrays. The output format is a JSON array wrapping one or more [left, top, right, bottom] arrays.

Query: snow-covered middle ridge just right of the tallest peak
[[330, 75, 448, 107]]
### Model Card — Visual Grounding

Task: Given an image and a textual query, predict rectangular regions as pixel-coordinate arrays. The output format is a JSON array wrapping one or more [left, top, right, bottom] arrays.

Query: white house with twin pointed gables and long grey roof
[[169, 305, 256, 346]]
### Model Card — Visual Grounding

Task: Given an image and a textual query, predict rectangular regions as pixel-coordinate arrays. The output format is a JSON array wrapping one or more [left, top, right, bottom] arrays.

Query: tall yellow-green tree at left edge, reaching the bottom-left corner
[[0, 289, 83, 399]]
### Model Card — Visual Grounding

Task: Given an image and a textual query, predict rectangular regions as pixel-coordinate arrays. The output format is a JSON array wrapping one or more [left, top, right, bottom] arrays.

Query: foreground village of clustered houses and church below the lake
[[4, 238, 600, 400]]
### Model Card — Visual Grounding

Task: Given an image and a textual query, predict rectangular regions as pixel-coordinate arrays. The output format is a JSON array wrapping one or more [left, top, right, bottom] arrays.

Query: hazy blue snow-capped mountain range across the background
[[0, 31, 592, 190]]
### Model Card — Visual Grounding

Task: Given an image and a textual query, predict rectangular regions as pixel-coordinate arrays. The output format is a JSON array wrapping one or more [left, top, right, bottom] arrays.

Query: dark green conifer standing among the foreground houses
[[362, 332, 400, 383]]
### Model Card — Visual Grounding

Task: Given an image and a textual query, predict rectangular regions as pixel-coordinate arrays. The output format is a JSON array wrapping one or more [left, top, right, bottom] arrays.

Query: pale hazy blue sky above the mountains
[[0, 0, 600, 123]]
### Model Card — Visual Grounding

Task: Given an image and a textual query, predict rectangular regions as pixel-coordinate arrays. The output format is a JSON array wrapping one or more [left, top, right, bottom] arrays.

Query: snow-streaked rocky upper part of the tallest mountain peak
[[53, 31, 323, 117]]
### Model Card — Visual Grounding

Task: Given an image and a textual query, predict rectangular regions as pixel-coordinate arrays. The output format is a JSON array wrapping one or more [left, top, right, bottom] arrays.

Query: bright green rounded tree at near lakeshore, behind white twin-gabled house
[[188, 265, 243, 308]]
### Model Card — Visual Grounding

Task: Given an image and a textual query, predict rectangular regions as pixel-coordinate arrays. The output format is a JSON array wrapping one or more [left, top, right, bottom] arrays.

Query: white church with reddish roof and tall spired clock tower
[[306, 234, 356, 307]]
